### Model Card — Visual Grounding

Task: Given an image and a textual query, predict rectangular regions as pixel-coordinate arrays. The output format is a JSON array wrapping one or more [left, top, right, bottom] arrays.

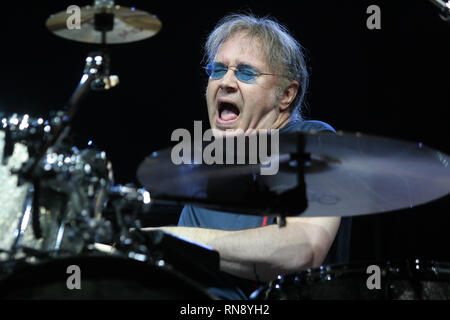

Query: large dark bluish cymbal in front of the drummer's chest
[[137, 132, 450, 217]]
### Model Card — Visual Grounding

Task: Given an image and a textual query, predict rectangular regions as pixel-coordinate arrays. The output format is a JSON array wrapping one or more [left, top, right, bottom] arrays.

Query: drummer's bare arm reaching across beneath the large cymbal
[[144, 217, 340, 281]]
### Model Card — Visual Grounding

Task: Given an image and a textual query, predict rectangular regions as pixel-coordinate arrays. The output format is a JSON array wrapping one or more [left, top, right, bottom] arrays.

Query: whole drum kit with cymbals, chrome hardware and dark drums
[[0, 0, 450, 299]]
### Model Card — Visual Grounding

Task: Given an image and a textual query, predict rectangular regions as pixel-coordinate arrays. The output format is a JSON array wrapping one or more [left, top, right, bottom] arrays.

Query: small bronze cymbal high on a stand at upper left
[[45, 6, 162, 44]]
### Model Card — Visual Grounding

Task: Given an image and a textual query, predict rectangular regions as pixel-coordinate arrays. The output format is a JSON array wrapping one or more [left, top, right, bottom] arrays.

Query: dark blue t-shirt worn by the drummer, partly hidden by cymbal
[[178, 120, 351, 299]]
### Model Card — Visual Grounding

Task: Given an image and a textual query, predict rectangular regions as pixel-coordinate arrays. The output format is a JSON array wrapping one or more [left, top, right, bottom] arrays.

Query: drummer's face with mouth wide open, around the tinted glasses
[[206, 33, 290, 134]]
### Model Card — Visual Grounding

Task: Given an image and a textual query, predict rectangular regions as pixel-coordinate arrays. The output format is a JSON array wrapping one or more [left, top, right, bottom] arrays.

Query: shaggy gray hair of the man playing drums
[[205, 13, 308, 119]]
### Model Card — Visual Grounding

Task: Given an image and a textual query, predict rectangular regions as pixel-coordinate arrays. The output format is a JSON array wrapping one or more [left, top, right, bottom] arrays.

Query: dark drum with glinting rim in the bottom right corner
[[251, 259, 450, 300]]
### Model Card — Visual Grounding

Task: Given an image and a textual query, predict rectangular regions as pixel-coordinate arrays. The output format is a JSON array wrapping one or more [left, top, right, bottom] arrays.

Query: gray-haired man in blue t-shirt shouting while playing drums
[[144, 14, 351, 299]]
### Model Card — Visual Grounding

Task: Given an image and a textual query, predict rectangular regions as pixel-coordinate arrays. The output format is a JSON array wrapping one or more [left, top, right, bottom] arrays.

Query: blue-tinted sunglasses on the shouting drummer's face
[[205, 62, 277, 83]]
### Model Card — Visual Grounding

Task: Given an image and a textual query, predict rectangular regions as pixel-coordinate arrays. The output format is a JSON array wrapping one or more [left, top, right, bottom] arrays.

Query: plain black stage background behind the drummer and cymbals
[[0, 0, 450, 260]]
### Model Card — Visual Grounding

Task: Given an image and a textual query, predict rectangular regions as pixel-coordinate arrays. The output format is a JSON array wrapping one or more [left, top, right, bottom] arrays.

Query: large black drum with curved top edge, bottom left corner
[[0, 255, 214, 300]]
